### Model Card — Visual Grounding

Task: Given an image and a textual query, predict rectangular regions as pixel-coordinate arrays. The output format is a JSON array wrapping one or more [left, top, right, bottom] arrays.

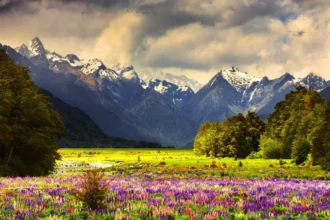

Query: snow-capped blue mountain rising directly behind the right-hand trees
[[182, 67, 330, 123]]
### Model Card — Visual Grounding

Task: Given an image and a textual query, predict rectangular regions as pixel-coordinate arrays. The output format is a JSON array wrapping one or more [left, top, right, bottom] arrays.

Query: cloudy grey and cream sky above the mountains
[[0, 0, 330, 83]]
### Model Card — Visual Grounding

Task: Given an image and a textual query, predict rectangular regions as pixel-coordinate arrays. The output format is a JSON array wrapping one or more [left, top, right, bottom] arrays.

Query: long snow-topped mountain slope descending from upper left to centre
[[10, 38, 198, 146]]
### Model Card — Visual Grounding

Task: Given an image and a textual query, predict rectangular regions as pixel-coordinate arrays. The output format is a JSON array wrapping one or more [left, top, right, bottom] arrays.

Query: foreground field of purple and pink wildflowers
[[0, 172, 330, 220]]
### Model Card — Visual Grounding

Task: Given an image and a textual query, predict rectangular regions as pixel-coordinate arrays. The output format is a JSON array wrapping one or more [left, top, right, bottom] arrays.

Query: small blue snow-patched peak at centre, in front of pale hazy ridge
[[148, 79, 195, 107]]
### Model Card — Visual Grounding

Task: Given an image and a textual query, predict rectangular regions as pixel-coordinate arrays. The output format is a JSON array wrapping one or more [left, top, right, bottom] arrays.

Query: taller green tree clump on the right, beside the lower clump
[[260, 87, 325, 161]]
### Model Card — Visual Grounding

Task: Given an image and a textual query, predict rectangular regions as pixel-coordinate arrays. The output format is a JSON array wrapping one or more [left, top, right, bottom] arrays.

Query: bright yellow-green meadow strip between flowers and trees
[[56, 148, 330, 180]]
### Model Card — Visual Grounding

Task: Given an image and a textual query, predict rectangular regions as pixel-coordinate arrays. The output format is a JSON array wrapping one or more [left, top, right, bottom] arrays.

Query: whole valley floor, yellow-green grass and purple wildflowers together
[[0, 149, 330, 220]]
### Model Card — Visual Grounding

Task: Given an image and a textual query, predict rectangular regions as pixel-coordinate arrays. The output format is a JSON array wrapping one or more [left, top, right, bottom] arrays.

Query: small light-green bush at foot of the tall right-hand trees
[[260, 136, 282, 159]]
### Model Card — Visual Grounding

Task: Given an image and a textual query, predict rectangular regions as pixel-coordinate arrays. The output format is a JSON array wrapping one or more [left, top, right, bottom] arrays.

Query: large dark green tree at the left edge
[[0, 51, 64, 176]]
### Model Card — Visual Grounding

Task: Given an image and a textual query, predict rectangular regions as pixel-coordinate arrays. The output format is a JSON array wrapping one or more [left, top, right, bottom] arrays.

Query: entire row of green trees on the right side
[[194, 86, 330, 169]]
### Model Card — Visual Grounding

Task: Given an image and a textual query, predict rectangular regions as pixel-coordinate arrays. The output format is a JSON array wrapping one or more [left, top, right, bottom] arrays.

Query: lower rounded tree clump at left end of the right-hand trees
[[194, 112, 265, 158]]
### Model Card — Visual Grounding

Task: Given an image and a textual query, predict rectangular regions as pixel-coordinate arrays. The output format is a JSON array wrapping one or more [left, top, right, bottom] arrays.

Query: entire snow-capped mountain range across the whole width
[[0, 38, 330, 147]]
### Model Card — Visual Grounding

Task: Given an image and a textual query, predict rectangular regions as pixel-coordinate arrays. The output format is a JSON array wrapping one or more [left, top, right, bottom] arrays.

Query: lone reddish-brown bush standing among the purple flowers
[[73, 169, 108, 210]]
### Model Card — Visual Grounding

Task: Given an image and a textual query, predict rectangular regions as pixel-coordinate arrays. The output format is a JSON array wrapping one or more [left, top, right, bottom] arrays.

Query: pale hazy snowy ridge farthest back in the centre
[[140, 70, 202, 93]]
